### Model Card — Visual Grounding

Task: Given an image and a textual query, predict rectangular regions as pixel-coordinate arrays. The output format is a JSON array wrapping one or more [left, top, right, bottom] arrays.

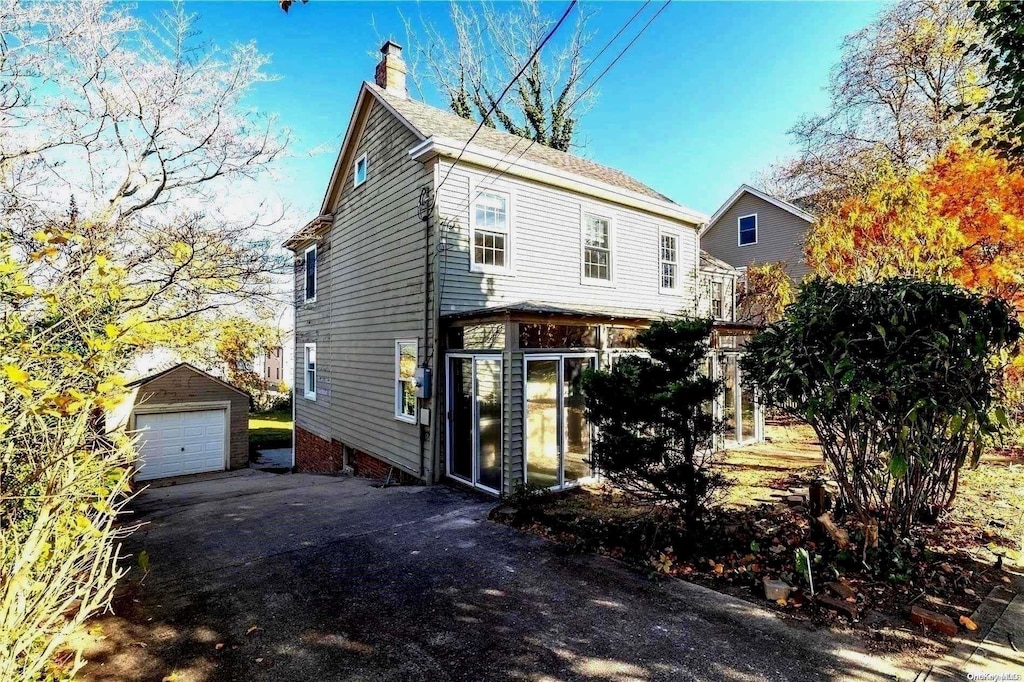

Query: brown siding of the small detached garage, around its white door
[[128, 366, 249, 469]]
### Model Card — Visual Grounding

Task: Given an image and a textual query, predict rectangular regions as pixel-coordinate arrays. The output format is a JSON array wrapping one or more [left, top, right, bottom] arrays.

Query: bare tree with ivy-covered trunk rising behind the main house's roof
[[404, 0, 594, 152]]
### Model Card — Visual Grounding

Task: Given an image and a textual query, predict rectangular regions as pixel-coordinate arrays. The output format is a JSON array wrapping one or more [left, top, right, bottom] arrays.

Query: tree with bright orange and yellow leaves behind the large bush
[[806, 146, 1024, 313]]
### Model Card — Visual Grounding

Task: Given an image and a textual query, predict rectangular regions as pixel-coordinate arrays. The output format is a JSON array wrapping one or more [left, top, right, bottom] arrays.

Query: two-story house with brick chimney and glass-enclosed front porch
[[286, 42, 760, 494]]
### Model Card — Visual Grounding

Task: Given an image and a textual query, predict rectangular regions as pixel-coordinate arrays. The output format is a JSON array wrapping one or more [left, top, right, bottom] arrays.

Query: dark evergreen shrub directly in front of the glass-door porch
[[584, 321, 723, 523]]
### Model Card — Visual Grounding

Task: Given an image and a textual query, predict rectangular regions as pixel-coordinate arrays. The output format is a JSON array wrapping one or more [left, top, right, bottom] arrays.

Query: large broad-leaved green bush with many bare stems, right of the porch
[[742, 279, 1021, 538]]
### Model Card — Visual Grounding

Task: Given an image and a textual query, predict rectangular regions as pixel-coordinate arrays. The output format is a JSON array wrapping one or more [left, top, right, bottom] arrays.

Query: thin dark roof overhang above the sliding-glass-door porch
[[441, 301, 684, 324]]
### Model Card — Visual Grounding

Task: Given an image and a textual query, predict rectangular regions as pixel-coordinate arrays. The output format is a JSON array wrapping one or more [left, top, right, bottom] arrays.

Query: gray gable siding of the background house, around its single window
[[700, 193, 810, 281]]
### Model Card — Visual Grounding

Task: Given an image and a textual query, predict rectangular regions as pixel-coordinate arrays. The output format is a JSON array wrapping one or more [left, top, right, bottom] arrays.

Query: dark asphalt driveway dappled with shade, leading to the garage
[[83, 471, 892, 682]]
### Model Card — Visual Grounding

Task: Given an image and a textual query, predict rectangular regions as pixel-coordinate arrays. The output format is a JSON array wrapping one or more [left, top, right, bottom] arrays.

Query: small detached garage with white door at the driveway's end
[[114, 364, 249, 481]]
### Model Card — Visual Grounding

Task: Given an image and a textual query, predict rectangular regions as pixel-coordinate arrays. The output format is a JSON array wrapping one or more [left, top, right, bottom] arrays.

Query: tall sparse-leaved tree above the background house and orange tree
[[762, 0, 986, 208]]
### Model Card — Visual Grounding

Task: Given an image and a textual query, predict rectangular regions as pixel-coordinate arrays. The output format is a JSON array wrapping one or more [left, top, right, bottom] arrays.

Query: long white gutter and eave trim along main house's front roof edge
[[409, 137, 708, 229]]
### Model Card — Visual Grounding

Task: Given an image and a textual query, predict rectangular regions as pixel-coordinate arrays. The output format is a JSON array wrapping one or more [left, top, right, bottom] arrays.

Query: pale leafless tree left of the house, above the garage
[[0, 0, 289, 318]]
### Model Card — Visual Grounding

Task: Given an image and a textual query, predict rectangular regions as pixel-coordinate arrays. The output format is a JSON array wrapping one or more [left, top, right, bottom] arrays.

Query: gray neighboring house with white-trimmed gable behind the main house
[[700, 184, 814, 282]]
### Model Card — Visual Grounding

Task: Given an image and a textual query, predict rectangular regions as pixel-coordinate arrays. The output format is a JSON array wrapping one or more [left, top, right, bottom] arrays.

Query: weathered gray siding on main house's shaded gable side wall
[[295, 98, 436, 475]]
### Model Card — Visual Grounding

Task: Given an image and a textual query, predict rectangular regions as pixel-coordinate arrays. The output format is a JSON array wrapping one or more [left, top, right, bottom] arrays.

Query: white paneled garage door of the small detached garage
[[135, 410, 227, 480]]
